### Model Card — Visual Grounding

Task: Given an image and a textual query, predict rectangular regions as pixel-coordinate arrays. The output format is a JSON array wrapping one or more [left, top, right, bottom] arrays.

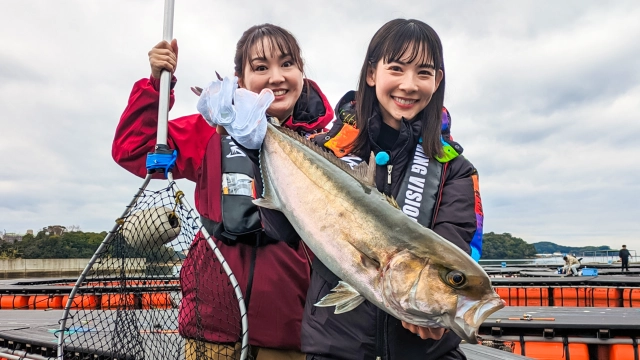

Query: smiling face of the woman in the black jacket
[[367, 43, 443, 129]]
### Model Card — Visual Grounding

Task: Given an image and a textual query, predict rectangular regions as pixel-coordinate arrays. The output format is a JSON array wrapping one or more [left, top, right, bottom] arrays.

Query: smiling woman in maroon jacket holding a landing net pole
[[112, 24, 333, 360]]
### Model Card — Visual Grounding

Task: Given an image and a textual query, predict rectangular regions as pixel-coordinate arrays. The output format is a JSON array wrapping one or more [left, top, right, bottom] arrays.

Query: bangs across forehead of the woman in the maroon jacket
[[243, 27, 303, 71]]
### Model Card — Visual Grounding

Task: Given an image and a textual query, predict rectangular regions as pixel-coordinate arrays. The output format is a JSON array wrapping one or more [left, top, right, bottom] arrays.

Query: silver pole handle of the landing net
[[156, 0, 175, 149]]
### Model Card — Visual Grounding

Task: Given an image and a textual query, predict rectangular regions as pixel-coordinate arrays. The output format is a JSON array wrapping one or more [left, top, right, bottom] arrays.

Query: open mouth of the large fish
[[447, 296, 504, 344]]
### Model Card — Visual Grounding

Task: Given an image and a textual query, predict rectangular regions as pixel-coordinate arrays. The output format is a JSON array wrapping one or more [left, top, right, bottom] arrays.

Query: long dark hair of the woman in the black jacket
[[353, 19, 445, 159]]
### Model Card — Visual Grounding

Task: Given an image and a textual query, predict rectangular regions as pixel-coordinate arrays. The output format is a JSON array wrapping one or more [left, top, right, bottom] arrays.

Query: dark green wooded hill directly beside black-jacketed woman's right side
[[482, 232, 536, 259]]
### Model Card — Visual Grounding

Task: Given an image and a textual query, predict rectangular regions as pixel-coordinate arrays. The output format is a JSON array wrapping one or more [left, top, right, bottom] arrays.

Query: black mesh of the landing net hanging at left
[[58, 183, 244, 360]]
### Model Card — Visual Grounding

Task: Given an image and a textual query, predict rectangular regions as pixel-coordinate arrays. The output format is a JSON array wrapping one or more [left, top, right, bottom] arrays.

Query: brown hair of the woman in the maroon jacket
[[233, 24, 304, 79]]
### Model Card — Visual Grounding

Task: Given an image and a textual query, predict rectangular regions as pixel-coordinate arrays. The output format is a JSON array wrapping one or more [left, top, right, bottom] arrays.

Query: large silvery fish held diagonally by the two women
[[255, 124, 504, 344]]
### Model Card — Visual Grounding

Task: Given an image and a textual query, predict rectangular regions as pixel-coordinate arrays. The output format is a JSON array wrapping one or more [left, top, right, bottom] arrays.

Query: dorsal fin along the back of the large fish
[[270, 125, 376, 189]]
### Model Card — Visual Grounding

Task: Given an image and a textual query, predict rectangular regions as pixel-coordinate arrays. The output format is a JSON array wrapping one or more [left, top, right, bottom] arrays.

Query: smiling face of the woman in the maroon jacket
[[238, 38, 304, 121]]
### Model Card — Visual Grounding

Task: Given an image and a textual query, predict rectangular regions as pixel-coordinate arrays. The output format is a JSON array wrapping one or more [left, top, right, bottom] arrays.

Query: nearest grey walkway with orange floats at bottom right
[[478, 306, 640, 360]]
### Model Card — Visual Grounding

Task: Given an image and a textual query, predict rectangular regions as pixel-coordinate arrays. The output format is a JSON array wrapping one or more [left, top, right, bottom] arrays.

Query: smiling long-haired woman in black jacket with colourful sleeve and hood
[[302, 19, 483, 360]]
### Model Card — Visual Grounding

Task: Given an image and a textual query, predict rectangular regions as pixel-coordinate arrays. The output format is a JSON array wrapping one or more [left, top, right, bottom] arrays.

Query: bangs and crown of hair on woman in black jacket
[[373, 22, 442, 69]]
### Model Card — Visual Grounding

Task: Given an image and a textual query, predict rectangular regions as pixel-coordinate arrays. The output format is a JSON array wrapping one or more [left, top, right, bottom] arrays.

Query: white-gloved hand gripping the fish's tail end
[[197, 77, 275, 149]]
